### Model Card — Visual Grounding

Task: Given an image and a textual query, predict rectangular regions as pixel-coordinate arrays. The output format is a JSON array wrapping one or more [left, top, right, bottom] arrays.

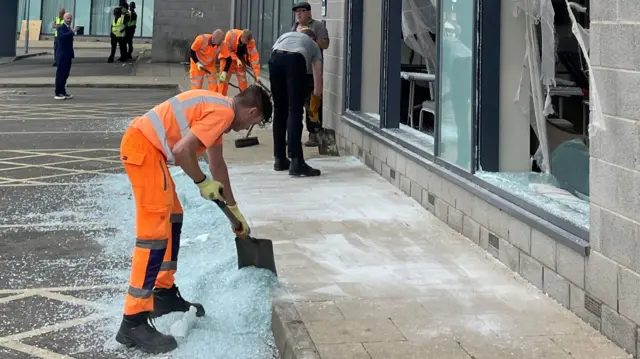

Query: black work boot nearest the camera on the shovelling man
[[116, 312, 178, 354]]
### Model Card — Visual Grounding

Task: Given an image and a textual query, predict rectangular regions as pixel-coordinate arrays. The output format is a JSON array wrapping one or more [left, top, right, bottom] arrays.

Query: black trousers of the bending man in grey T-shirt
[[269, 50, 308, 159]]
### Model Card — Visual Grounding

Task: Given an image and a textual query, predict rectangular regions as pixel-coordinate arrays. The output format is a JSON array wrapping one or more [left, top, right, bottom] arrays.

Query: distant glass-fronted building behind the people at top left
[[16, 0, 155, 37]]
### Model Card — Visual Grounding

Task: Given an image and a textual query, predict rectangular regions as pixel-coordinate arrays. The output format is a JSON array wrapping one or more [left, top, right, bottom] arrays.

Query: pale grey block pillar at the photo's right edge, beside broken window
[[587, 0, 640, 354]]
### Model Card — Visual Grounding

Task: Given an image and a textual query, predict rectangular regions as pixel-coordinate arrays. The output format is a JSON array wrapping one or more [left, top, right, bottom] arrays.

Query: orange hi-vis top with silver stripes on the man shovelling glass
[[131, 90, 235, 164]]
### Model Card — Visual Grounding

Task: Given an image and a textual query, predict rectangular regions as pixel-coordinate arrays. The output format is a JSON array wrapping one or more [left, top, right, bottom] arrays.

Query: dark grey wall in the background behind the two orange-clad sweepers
[[152, 0, 232, 62]]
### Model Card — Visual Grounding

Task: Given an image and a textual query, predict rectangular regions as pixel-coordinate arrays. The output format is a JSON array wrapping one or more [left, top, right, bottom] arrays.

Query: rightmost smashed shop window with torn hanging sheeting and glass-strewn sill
[[476, 0, 589, 233]]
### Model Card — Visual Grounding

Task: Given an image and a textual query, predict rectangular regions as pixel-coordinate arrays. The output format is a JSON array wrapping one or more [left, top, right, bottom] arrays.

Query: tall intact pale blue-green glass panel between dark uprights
[[437, 0, 474, 169]]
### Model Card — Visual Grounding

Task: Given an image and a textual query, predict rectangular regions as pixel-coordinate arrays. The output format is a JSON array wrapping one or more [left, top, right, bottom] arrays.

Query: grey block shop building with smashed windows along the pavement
[[234, 0, 640, 357]]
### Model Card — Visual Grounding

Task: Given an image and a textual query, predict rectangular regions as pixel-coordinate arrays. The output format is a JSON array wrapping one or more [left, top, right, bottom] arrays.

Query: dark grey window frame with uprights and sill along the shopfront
[[344, 0, 589, 248]]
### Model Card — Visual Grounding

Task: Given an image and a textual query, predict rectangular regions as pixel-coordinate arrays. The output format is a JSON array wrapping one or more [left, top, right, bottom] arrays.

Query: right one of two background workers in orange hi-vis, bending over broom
[[218, 29, 260, 96]]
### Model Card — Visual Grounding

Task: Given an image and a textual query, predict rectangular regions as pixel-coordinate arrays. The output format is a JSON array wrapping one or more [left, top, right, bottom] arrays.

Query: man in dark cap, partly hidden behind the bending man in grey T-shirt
[[291, 1, 329, 147]]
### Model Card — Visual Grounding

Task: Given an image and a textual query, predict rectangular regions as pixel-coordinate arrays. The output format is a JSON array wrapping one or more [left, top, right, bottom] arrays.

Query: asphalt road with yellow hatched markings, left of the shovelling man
[[0, 87, 174, 359]]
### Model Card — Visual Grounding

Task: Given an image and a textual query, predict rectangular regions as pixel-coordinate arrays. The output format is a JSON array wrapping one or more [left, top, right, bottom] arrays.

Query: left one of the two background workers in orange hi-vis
[[189, 29, 224, 91]]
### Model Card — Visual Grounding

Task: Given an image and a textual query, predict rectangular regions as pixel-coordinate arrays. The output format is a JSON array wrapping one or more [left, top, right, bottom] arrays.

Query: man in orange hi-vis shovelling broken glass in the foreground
[[116, 85, 273, 353]]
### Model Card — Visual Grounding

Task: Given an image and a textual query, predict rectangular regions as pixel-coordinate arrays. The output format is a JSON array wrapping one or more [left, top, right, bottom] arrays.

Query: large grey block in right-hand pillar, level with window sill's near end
[[592, 208, 640, 270]]
